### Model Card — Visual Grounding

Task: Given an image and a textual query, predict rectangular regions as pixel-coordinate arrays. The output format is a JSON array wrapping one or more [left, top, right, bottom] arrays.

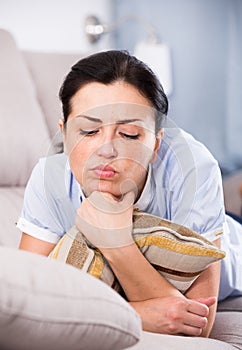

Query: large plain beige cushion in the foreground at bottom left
[[0, 247, 141, 350]]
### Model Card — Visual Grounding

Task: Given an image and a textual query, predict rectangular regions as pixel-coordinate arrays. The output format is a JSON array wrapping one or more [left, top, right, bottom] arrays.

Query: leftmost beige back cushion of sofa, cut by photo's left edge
[[0, 29, 49, 186]]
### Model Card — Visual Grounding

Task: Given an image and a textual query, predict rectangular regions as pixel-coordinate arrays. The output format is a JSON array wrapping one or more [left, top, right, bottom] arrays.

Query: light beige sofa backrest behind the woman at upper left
[[0, 29, 83, 186]]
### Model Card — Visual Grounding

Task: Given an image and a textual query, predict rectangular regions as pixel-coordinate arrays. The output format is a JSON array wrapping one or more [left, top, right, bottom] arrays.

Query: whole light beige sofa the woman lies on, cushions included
[[0, 29, 242, 350]]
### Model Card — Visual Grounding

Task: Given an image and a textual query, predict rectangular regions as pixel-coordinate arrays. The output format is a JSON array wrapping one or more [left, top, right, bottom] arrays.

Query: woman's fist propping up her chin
[[75, 191, 134, 249]]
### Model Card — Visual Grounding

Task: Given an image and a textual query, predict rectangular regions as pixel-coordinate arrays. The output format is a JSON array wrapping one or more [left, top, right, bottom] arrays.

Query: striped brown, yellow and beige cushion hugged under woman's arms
[[50, 212, 225, 293]]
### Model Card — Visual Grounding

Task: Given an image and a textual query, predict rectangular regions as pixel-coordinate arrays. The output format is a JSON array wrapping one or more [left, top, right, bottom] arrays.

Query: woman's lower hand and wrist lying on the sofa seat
[[130, 296, 216, 336]]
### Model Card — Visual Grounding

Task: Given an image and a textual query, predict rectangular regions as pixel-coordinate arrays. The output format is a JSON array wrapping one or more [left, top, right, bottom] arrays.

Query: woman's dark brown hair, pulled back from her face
[[59, 50, 168, 131]]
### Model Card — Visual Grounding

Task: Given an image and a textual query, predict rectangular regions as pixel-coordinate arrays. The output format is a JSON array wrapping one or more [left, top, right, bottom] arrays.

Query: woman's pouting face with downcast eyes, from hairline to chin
[[62, 81, 161, 198]]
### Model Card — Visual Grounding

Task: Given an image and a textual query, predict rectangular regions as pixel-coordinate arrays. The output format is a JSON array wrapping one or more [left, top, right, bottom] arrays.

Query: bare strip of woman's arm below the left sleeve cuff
[[19, 232, 55, 256]]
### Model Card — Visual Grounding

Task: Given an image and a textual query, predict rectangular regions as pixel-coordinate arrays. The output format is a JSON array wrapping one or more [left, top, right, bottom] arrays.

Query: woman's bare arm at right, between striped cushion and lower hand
[[186, 239, 221, 337]]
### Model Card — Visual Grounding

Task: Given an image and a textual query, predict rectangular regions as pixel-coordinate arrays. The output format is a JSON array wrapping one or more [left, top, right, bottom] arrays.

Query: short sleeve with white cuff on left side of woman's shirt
[[17, 158, 64, 243]]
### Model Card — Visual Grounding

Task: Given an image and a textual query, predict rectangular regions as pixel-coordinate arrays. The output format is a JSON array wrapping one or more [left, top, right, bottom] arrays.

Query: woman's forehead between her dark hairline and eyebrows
[[68, 81, 155, 128]]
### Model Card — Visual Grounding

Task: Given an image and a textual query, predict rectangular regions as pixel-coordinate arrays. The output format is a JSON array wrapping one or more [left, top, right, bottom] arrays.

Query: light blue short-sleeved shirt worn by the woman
[[17, 128, 242, 300]]
